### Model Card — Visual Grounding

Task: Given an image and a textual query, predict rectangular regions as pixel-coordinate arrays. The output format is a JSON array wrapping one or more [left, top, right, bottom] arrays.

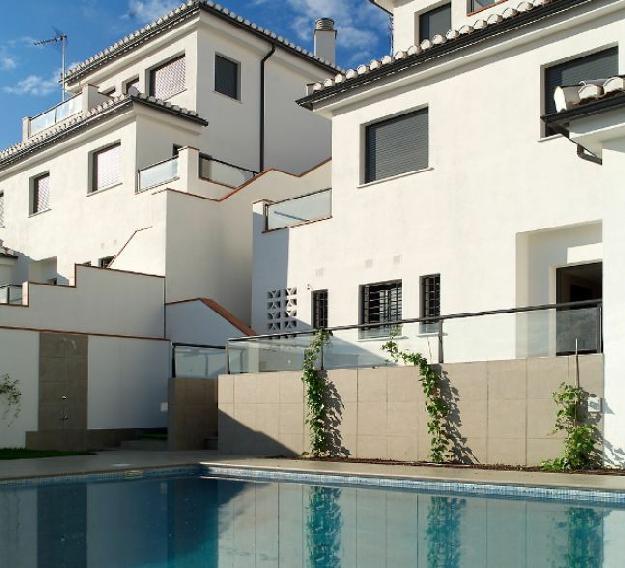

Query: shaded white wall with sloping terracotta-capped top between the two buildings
[[166, 162, 331, 322]]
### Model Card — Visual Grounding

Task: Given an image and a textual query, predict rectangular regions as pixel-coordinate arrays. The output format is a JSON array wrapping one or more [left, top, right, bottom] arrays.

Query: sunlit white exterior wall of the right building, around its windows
[[252, 3, 625, 460]]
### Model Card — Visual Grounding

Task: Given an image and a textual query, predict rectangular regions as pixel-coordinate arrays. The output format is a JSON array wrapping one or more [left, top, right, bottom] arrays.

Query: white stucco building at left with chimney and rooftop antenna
[[0, 0, 338, 447]]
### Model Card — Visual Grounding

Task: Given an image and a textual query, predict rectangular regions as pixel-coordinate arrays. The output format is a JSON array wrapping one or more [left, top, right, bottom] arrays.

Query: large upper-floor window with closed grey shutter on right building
[[365, 109, 428, 183]]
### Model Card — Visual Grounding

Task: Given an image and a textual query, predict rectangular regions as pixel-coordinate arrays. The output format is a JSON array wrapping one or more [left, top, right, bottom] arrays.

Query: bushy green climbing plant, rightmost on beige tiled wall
[[541, 383, 601, 471]]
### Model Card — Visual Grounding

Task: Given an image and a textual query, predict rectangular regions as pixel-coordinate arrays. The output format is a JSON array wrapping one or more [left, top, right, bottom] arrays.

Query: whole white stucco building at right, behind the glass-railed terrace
[[252, 0, 625, 461]]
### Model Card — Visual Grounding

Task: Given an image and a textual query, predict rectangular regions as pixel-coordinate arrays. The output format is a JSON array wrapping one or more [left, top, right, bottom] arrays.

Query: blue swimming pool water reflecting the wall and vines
[[0, 475, 625, 568]]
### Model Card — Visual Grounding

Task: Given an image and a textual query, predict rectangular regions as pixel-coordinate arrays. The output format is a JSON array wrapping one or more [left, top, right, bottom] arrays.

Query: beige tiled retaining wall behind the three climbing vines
[[218, 355, 603, 465]]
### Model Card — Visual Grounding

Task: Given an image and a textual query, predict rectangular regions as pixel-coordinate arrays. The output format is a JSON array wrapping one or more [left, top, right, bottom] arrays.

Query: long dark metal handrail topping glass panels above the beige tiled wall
[[228, 300, 603, 343]]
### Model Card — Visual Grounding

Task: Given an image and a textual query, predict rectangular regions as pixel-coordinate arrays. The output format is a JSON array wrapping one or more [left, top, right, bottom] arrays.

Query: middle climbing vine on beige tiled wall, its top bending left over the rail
[[382, 331, 451, 463]]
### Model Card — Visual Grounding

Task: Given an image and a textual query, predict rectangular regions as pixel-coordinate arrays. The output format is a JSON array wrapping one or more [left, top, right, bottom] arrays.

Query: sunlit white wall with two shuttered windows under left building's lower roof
[[0, 107, 201, 283]]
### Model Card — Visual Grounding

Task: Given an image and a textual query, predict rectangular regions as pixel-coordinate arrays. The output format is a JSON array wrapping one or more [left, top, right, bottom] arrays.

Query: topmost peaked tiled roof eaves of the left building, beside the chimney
[[65, 0, 340, 83]]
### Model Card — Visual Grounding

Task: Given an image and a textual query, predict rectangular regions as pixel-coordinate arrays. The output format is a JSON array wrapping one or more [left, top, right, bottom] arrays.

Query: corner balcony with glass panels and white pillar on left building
[[137, 146, 256, 199]]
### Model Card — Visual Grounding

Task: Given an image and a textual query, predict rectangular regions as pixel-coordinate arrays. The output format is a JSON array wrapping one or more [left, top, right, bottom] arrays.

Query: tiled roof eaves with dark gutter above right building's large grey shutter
[[297, 0, 593, 109]]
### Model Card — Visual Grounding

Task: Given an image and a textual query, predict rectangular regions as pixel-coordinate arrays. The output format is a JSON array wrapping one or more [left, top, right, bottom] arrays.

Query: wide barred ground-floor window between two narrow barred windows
[[360, 280, 401, 337]]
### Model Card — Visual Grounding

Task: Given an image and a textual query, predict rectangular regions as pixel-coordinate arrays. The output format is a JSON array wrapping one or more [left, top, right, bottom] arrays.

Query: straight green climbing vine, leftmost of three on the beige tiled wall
[[302, 329, 330, 456]]
